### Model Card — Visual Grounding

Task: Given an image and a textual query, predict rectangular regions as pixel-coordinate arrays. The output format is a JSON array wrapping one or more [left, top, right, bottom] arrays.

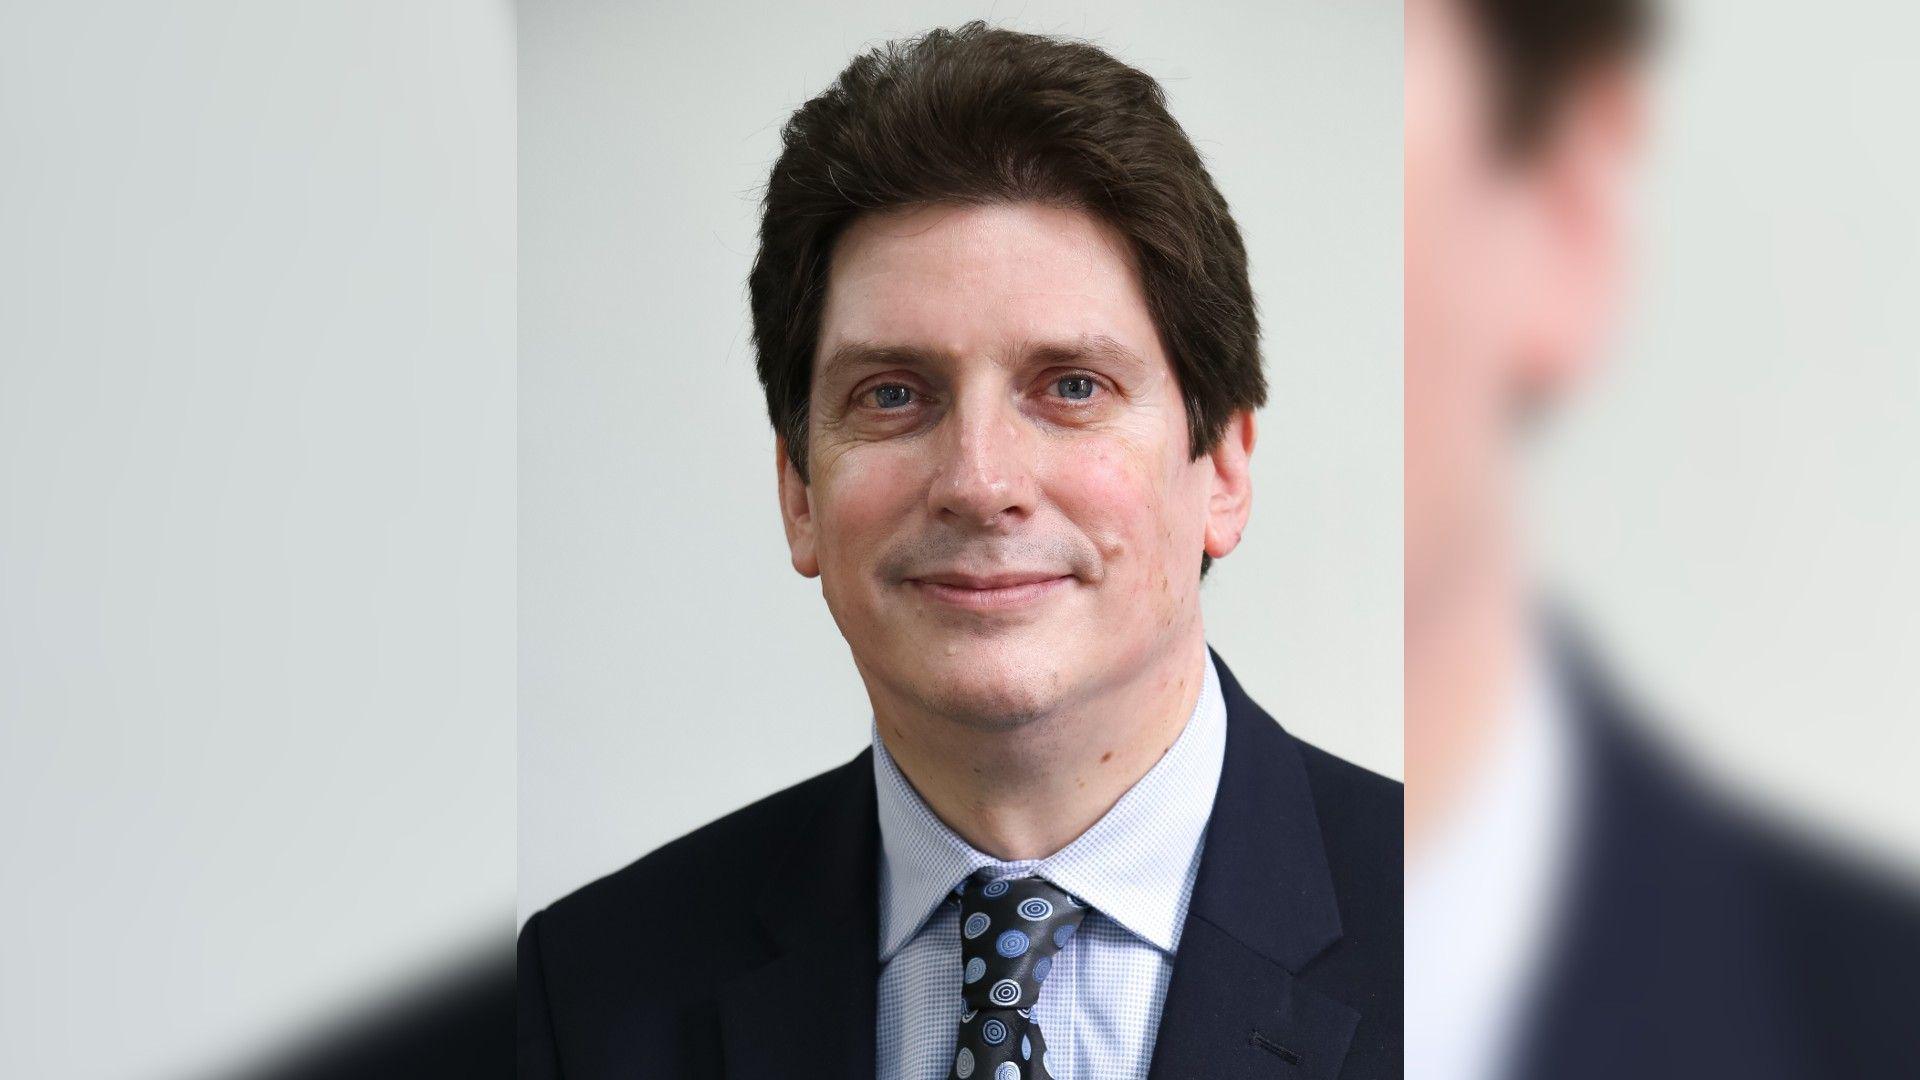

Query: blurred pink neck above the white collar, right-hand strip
[[1404, 526, 1526, 859]]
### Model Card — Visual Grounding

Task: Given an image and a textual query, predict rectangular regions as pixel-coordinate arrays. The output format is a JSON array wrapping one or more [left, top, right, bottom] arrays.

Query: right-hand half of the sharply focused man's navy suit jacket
[[1175, 655, 1404, 1080]]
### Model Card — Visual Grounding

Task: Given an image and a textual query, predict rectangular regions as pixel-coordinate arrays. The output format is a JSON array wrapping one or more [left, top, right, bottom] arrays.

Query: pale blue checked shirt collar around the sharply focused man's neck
[[874, 655, 1227, 961]]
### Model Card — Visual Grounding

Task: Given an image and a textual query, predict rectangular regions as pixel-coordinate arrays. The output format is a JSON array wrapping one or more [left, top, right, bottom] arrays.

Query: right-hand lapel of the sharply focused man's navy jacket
[[1148, 655, 1359, 1080]]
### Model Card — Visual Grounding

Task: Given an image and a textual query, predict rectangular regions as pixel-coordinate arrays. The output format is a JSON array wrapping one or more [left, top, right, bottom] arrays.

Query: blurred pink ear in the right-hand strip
[[1521, 65, 1644, 402]]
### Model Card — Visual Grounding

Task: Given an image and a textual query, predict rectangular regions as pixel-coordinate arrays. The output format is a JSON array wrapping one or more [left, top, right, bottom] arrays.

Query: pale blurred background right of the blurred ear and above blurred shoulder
[[1526, 0, 1920, 863]]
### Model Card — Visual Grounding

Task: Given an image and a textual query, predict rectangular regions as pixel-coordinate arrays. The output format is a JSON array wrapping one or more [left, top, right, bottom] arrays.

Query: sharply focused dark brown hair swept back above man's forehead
[[749, 21, 1267, 479]]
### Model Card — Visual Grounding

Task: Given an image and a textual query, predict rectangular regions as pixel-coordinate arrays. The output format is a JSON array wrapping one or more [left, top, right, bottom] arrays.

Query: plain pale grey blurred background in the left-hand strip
[[0, 0, 515, 1080]]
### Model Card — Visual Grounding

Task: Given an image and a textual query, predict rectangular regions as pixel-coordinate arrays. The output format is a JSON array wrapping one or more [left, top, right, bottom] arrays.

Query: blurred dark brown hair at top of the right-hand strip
[[1465, 0, 1653, 156]]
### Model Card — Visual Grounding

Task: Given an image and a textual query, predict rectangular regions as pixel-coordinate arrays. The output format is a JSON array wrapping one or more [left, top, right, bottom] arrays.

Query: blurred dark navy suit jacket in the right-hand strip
[[1511, 615, 1920, 1080]]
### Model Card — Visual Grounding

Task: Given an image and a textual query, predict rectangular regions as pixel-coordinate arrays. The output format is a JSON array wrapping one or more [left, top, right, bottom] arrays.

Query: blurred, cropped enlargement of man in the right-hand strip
[[1405, 0, 1920, 1080]]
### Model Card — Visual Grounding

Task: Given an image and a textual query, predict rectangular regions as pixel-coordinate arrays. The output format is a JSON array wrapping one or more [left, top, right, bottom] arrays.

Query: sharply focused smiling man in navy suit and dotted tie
[[520, 23, 1400, 1080]]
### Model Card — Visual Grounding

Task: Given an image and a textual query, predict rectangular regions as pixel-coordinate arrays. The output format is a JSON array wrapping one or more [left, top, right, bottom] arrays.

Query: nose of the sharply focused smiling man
[[927, 392, 1037, 528]]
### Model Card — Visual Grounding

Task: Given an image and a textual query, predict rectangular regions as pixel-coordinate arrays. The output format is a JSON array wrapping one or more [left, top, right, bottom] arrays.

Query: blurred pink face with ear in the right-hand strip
[[1405, 0, 1634, 618]]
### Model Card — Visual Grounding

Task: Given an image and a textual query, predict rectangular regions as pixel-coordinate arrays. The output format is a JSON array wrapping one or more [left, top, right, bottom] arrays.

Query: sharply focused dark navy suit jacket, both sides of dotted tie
[[516, 655, 1402, 1080]]
